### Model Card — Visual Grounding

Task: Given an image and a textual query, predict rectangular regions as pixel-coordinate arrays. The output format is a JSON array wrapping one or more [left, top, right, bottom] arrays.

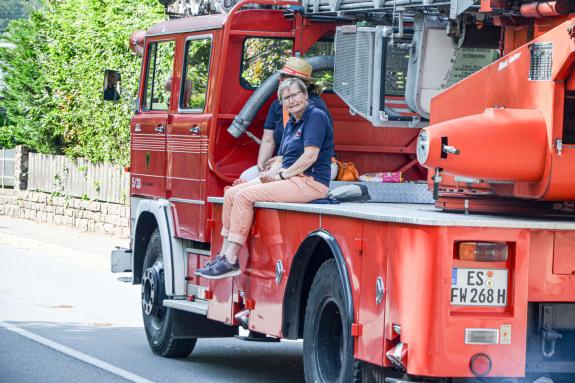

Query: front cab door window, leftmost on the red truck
[[143, 41, 175, 110]]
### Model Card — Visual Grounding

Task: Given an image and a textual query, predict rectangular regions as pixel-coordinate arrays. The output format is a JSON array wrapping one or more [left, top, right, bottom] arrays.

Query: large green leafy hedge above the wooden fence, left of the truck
[[0, 0, 165, 164]]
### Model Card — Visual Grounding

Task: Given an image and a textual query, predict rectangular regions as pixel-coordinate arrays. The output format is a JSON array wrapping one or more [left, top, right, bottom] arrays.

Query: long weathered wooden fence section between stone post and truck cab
[[28, 153, 130, 203]]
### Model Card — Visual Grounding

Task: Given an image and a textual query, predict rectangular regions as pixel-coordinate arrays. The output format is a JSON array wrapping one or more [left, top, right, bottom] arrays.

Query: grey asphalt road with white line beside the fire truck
[[0, 216, 304, 383]]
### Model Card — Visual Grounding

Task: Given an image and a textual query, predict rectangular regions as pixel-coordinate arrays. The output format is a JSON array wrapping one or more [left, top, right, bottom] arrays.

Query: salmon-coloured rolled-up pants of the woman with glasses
[[222, 174, 329, 245]]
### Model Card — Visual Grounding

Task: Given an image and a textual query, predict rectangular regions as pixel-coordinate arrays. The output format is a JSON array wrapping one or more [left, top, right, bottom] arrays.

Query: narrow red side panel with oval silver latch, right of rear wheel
[[356, 222, 388, 365]]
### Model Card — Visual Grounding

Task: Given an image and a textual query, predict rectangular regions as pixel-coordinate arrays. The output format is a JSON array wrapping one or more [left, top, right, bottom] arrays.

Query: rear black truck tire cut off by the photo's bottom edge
[[303, 259, 361, 383]]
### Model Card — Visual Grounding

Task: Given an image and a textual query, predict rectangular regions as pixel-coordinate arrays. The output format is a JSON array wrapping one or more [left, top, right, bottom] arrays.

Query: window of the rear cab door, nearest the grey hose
[[180, 37, 212, 112]]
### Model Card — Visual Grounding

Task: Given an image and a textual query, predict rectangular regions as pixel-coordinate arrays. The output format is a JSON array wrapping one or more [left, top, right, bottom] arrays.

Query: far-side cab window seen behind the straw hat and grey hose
[[240, 37, 293, 89]]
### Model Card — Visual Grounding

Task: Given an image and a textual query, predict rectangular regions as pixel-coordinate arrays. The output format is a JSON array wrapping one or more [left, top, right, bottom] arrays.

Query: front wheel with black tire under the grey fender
[[141, 229, 197, 358]]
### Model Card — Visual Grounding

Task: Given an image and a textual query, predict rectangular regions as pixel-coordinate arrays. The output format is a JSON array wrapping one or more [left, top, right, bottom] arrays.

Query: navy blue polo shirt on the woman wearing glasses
[[279, 104, 333, 186]]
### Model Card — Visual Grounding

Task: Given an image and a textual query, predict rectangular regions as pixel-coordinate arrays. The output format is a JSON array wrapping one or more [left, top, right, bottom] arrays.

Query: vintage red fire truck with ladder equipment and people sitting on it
[[112, 0, 575, 383]]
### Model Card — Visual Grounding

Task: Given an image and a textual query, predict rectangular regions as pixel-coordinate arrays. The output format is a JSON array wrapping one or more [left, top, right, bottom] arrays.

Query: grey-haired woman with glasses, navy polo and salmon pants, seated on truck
[[197, 78, 334, 279]]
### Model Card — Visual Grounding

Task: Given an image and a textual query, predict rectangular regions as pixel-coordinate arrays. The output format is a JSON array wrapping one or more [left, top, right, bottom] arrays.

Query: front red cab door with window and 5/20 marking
[[130, 39, 176, 198]]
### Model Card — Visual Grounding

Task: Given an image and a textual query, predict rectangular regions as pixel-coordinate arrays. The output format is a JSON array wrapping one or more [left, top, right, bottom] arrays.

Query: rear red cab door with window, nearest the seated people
[[166, 32, 213, 241]]
